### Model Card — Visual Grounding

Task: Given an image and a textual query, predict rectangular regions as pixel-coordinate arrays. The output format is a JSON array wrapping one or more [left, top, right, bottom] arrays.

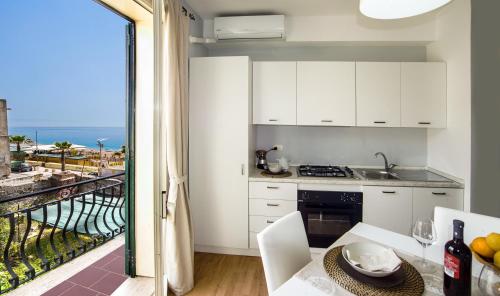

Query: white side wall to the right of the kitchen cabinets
[[427, 0, 471, 211]]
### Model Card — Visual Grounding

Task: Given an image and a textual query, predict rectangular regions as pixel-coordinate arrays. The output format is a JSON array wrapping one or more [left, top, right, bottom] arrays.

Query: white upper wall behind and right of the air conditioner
[[204, 14, 436, 43]]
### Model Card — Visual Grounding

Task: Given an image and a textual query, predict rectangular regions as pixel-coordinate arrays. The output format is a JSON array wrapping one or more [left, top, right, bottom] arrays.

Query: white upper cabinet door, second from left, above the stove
[[297, 62, 356, 126]]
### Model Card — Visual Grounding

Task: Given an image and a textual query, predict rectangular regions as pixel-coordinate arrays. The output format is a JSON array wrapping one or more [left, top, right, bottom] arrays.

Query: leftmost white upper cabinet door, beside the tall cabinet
[[253, 62, 297, 125]]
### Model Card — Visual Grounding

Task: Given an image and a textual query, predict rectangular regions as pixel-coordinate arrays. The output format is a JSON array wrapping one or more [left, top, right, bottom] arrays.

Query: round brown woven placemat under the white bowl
[[323, 246, 425, 296]]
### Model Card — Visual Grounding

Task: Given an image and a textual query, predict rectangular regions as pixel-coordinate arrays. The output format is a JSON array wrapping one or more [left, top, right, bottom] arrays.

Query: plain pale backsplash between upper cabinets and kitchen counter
[[255, 126, 427, 166]]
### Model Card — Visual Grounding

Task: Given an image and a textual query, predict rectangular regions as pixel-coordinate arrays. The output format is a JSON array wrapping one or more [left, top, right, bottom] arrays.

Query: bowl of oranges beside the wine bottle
[[470, 232, 500, 272]]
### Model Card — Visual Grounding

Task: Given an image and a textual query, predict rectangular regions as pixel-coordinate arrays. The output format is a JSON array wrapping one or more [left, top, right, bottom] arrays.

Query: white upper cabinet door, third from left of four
[[356, 62, 401, 127]]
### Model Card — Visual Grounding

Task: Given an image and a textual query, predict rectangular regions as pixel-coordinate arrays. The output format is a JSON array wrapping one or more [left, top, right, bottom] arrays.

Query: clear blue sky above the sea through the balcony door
[[0, 0, 127, 127]]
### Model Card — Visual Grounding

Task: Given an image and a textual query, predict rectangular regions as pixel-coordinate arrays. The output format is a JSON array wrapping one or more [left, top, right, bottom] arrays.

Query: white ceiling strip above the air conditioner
[[185, 0, 359, 19]]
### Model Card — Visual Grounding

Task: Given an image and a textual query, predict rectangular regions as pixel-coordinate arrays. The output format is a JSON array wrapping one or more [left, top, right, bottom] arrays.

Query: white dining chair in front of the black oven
[[257, 212, 311, 294]]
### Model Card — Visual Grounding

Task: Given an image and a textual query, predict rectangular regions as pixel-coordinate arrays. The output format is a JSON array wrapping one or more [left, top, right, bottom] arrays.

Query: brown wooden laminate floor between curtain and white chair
[[187, 253, 267, 296]]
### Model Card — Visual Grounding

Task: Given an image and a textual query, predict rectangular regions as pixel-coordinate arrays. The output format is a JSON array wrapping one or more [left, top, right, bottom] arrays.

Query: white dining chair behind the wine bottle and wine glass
[[434, 207, 500, 276]]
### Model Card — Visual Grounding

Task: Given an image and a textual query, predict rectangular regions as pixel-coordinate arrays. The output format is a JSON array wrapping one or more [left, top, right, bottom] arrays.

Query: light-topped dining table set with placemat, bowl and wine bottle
[[271, 222, 481, 296]]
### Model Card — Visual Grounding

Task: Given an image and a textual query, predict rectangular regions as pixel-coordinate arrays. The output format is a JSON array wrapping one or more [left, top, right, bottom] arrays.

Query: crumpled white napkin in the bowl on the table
[[347, 249, 402, 272]]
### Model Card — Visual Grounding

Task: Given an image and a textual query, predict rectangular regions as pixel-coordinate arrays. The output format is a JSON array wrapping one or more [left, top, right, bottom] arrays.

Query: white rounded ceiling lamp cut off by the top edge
[[359, 0, 452, 20]]
